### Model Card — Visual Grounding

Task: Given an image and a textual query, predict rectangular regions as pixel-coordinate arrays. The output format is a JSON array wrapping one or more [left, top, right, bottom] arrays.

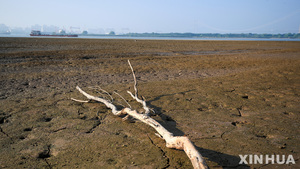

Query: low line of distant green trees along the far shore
[[81, 32, 300, 39]]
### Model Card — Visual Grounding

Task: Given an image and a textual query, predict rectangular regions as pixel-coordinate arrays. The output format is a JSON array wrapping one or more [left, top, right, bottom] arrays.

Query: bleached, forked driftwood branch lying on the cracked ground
[[71, 60, 208, 169]]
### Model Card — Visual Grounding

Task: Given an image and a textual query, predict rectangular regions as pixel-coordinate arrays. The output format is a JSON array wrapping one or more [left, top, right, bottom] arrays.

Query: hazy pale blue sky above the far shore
[[0, 0, 300, 34]]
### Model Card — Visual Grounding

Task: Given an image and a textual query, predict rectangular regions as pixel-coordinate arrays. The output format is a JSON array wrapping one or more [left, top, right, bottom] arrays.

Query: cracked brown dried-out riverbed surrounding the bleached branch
[[0, 38, 300, 169]]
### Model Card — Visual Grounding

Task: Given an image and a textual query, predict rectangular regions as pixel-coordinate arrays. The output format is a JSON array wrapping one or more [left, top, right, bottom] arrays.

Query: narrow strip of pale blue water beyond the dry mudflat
[[0, 34, 300, 41]]
